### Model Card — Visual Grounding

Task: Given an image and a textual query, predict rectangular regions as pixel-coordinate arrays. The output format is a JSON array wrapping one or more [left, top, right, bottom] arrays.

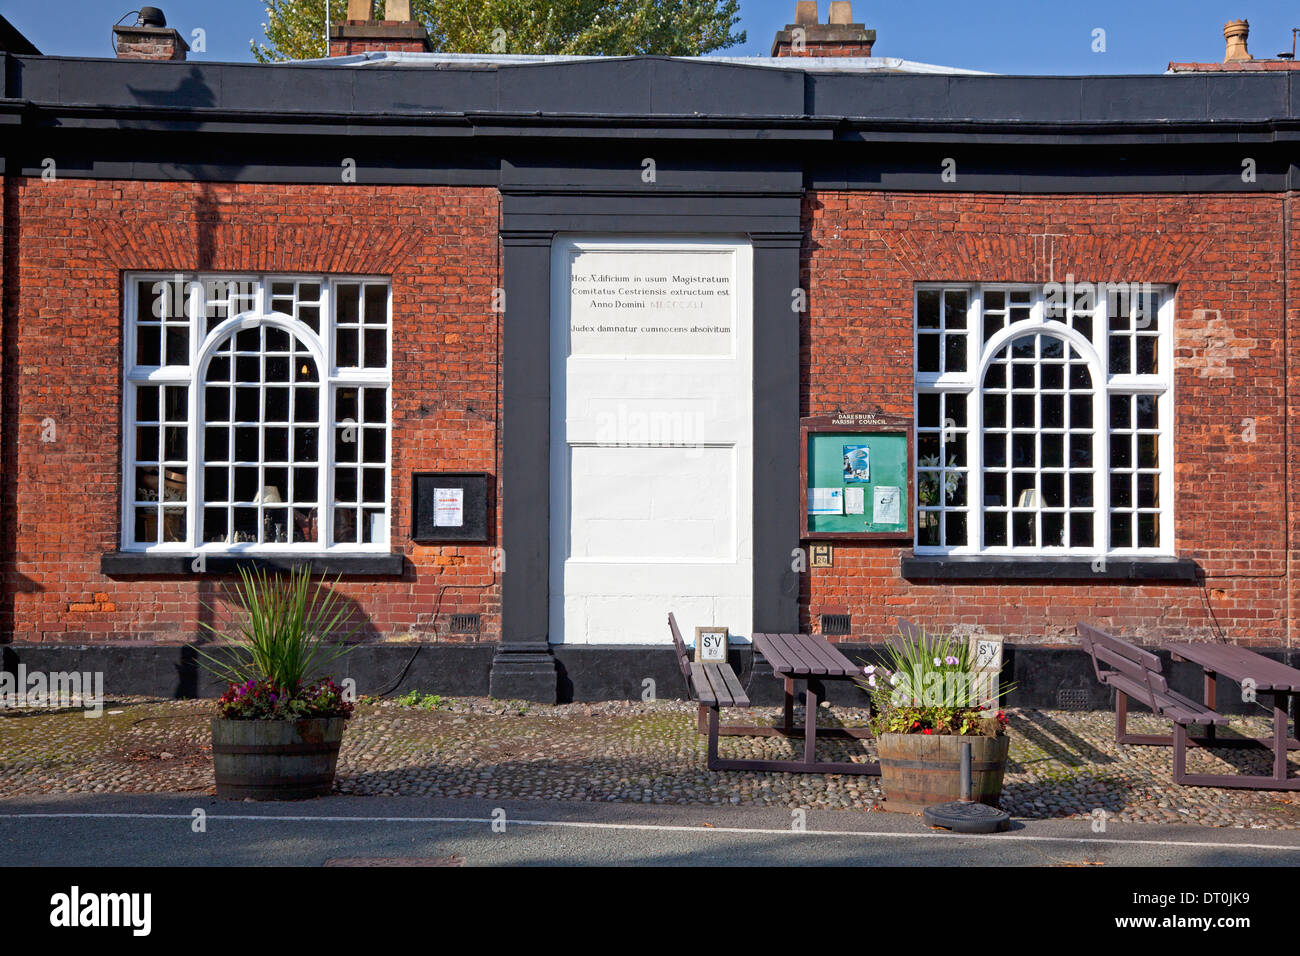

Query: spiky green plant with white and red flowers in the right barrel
[[858, 630, 1011, 737]]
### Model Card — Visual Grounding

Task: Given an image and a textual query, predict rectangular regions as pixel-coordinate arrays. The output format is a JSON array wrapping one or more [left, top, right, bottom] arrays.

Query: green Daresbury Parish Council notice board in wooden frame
[[801, 412, 913, 538]]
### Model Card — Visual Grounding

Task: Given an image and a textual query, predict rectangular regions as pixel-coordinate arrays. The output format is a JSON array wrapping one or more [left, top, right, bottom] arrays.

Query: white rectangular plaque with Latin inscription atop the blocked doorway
[[569, 250, 736, 355]]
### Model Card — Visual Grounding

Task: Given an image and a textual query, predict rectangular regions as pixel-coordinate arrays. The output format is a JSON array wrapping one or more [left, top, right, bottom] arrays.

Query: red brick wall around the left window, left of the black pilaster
[[0, 178, 501, 641]]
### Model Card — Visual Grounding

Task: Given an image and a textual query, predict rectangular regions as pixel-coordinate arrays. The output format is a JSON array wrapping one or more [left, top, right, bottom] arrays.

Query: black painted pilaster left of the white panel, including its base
[[490, 230, 559, 704]]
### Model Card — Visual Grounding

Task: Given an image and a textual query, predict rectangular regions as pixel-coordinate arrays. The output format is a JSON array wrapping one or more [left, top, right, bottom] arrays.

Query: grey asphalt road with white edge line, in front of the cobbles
[[0, 795, 1300, 866]]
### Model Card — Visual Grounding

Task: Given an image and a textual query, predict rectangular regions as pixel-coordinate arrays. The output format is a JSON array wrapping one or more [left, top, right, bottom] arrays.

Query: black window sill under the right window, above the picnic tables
[[901, 554, 1200, 581]]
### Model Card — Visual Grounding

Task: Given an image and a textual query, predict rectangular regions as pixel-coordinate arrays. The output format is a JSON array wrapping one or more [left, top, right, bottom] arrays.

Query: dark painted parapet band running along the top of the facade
[[15, 56, 1297, 131]]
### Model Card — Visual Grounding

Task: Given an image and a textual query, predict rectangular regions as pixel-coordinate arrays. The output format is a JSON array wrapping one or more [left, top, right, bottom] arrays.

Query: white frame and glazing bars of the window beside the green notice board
[[913, 282, 1177, 558]]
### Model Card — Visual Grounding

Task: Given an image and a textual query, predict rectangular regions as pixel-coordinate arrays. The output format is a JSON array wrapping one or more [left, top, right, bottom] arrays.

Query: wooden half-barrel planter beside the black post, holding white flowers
[[878, 734, 1011, 813]]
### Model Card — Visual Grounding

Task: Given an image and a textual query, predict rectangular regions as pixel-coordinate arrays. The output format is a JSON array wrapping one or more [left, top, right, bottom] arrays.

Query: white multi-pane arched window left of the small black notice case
[[122, 276, 391, 553]]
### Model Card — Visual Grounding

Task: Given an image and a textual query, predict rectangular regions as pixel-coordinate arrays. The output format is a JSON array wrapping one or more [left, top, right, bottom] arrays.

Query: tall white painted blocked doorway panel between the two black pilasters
[[550, 238, 753, 644]]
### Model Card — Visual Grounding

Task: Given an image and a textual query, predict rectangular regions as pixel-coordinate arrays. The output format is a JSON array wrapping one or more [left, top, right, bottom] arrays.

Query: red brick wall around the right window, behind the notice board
[[802, 191, 1300, 645]]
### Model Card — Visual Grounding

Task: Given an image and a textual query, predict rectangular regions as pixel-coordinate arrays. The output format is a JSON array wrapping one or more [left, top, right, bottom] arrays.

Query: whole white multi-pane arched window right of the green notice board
[[915, 284, 1173, 555]]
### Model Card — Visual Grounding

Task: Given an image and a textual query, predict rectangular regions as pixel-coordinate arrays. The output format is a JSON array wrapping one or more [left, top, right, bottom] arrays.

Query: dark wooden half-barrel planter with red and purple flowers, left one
[[212, 717, 347, 800]]
